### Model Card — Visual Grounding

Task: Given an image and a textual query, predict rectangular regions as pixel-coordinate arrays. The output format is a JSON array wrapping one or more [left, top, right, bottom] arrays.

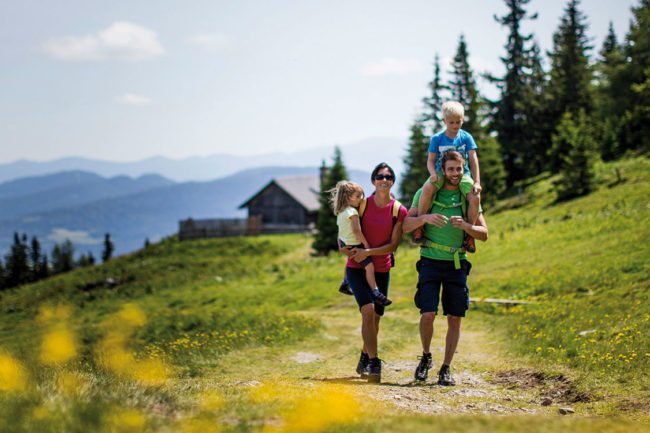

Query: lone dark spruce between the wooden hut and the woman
[[312, 147, 348, 255]]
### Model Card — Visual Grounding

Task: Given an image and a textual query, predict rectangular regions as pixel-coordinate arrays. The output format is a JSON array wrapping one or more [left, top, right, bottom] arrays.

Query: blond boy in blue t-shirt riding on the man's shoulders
[[413, 101, 482, 253]]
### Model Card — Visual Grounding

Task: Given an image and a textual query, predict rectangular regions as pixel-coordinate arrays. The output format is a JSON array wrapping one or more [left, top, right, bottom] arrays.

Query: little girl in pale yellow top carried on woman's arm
[[330, 180, 392, 306]]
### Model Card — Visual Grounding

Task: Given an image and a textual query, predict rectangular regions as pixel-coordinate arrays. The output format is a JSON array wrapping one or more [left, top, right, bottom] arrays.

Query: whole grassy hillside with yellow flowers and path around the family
[[0, 159, 650, 433]]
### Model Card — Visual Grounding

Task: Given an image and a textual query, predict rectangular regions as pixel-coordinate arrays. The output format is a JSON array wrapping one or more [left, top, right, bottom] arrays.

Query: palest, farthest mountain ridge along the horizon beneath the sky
[[0, 137, 406, 182]]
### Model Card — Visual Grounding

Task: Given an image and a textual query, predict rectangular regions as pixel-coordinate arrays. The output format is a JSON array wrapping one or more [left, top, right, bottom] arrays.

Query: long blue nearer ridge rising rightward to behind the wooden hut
[[0, 167, 370, 256]]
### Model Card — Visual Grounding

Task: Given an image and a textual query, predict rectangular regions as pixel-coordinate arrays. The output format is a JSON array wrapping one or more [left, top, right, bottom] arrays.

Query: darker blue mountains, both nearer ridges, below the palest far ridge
[[0, 166, 371, 257]]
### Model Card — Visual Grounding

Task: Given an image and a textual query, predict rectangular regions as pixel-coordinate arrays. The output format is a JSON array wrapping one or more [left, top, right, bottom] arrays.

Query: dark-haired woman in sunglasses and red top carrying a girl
[[340, 162, 407, 383]]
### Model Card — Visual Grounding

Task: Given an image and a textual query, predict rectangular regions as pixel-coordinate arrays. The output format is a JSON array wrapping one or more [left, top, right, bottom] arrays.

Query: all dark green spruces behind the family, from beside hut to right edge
[[312, 0, 650, 254]]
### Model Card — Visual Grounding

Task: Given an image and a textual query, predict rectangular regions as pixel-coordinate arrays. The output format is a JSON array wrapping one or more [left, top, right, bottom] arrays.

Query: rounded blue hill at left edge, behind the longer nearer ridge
[[0, 171, 175, 221]]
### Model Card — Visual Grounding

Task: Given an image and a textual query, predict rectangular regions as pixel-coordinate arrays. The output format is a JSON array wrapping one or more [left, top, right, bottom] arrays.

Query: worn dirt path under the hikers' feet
[[208, 299, 586, 415]]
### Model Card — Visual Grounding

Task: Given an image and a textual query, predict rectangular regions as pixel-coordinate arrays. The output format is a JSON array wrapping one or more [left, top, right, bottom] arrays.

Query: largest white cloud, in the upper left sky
[[43, 21, 165, 62]]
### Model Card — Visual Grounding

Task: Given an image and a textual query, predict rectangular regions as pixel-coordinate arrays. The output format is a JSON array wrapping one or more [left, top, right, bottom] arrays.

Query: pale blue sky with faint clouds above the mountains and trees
[[0, 0, 638, 163]]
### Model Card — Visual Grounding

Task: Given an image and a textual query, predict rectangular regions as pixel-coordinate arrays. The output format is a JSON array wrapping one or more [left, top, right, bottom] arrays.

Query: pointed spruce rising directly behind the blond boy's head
[[446, 34, 483, 136]]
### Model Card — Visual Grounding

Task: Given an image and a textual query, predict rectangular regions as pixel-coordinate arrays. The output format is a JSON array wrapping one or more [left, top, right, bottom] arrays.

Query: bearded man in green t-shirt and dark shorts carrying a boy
[[403, 151, 488, 386]]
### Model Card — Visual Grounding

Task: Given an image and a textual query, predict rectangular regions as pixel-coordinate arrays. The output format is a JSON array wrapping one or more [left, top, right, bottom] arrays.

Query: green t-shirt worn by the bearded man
[[413, 188, 467, 261]]
